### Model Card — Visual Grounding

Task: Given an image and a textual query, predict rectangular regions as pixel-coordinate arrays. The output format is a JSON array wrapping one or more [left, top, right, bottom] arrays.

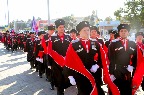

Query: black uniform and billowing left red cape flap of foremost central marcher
[[64, 39, 105, 95]]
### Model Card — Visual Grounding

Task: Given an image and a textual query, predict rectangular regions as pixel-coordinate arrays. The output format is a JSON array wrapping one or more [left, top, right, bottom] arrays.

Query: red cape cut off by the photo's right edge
[[132, 46, 144, 95]]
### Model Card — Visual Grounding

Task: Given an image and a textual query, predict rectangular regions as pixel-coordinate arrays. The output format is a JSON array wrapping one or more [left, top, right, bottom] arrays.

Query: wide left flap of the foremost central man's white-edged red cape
[[65, 44, 98, 95]]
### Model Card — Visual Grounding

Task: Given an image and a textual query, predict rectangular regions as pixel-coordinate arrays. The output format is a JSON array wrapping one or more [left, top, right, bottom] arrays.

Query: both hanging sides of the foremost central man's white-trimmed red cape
[[65, 44, 120, 95]]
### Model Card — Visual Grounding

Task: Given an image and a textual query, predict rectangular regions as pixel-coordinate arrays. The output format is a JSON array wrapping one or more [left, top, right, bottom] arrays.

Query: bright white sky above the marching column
[[0, 0, 126, 25]]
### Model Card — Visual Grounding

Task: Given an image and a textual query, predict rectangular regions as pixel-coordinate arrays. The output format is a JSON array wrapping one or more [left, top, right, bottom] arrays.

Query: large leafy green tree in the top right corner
[[114, 0, 144, 31]]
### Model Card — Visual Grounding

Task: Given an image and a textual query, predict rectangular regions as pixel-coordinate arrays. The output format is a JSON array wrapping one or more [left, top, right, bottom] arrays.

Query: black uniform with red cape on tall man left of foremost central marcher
[[48, 34, 72, 95]]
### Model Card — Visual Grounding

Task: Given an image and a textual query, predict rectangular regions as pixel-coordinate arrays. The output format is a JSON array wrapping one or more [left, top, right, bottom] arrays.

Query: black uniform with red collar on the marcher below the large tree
[[108, 38, 137, 95]]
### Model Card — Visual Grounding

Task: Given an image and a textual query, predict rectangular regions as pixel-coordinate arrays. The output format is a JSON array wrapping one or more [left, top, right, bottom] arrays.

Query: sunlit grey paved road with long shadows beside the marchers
[[0, 43, 144, 95]]
